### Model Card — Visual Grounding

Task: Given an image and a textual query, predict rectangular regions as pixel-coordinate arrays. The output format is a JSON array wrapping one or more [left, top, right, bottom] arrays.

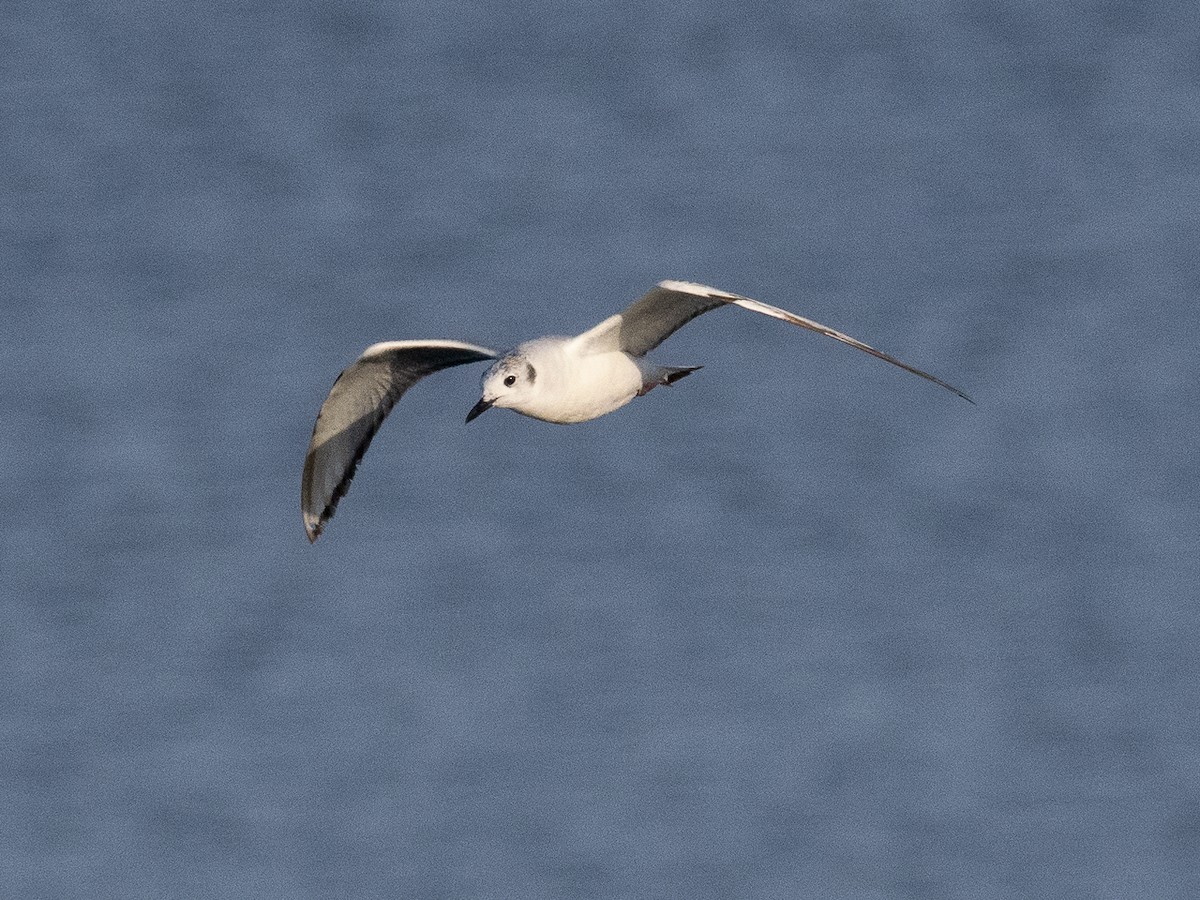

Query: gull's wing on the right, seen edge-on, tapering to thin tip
[[575, 281, 974, 403]]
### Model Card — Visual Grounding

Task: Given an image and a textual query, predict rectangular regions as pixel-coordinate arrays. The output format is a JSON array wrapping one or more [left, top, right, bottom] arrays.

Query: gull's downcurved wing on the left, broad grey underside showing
[[300, 341, 497, 541]]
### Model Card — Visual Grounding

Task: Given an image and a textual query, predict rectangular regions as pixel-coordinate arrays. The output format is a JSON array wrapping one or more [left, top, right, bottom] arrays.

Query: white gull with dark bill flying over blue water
[[300, 281, 974, 542]]
